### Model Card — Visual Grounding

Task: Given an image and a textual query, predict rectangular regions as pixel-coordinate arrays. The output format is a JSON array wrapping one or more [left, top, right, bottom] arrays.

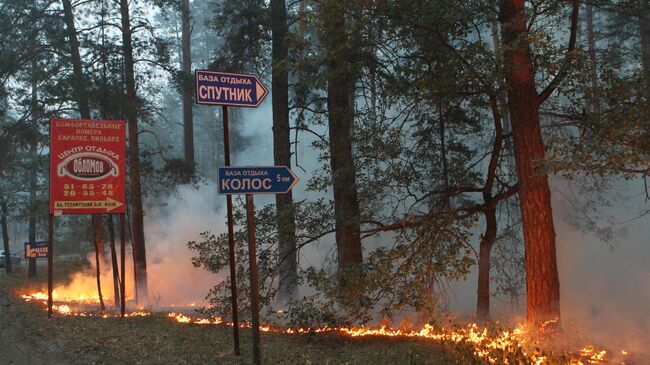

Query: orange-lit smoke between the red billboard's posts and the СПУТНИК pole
[[55, 185, 225, 309]]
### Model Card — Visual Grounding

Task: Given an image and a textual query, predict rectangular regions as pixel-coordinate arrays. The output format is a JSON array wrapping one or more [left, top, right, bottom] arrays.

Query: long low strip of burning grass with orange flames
[[15, 292, 633, 365]]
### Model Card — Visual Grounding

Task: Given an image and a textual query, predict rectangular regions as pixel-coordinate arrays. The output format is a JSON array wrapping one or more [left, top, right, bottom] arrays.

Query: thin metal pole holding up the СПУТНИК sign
[[222, 105, 239, 355]]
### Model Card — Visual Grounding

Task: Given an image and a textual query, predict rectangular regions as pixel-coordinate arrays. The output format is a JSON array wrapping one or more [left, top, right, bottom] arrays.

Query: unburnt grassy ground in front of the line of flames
[[0, 268, 482, 365]]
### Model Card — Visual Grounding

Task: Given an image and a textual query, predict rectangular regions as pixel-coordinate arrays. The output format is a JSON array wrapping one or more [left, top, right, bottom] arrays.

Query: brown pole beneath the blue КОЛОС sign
[[246, 194, 262, 365]]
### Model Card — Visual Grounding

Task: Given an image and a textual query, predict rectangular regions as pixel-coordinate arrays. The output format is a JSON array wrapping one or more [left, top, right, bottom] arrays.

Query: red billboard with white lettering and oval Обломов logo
[[50, 118, 126, 215]]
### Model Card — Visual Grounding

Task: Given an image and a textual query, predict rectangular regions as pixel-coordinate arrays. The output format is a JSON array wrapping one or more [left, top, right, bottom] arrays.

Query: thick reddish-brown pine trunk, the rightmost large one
[[501, 0, 560, 324]]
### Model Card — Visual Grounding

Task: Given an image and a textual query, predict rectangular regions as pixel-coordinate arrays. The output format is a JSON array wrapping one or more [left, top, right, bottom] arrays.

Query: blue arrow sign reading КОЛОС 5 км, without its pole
[[217, 166, 299, 195]]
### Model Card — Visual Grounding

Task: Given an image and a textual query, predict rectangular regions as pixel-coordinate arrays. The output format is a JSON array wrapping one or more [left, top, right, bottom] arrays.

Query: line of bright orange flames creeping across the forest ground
[[22, 292, 629, 365]]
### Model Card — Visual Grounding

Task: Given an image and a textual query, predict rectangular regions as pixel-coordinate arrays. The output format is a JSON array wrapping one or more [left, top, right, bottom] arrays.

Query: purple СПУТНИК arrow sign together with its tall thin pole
[[194, 70, 269, 355]]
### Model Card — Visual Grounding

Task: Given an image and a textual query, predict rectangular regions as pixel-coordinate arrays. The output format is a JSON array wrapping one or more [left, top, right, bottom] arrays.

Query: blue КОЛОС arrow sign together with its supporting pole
[[217, 166, 299, 365]]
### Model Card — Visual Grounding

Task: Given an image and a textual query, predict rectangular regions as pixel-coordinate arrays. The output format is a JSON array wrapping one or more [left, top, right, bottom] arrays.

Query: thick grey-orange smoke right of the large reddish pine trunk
[[553, 181, 650, 355]]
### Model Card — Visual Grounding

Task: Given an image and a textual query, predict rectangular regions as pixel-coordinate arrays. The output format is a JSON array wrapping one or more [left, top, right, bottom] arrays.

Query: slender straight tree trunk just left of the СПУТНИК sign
[[181, 0, 195, 172]]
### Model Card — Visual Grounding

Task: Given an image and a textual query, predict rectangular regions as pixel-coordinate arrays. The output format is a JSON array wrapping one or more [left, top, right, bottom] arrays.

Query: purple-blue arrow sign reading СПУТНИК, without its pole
[[195, 70, 269, 108]]
